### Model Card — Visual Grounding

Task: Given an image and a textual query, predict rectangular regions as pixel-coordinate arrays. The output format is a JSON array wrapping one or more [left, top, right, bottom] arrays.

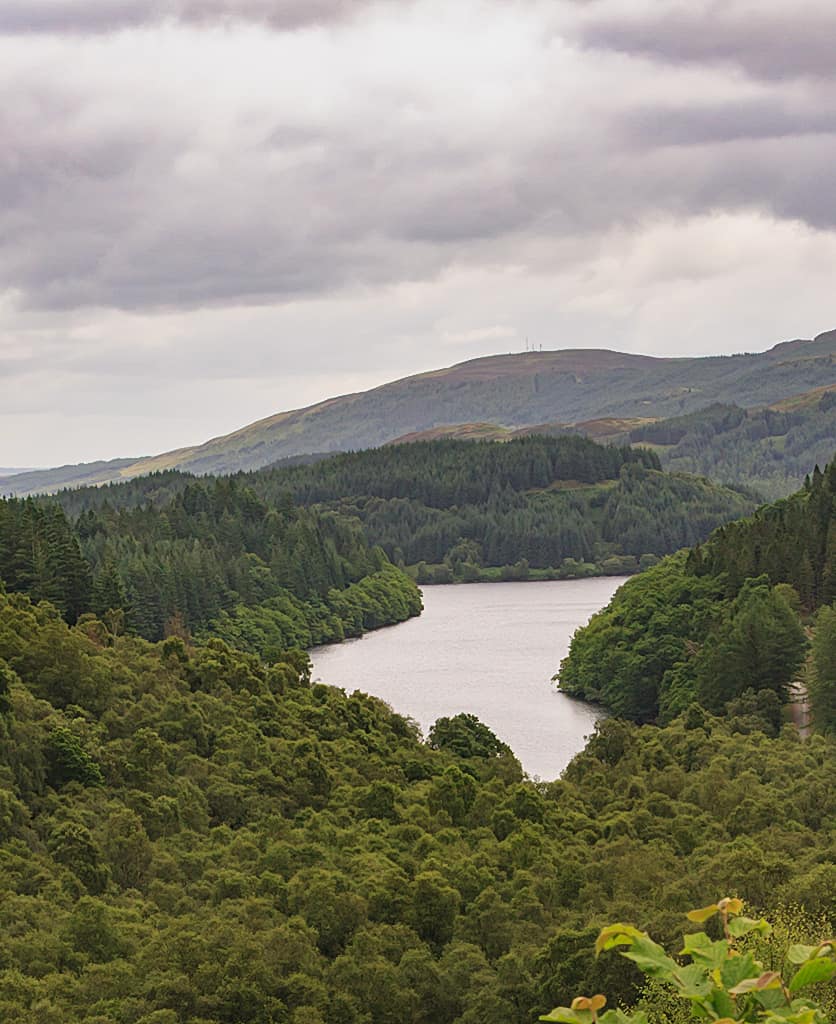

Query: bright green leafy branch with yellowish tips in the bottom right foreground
[[540, 898, 836, 1024]]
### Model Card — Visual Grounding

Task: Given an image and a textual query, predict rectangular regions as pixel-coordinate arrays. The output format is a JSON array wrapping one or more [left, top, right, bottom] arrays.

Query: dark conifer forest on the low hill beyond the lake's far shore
[[52, 435, 756, 583]]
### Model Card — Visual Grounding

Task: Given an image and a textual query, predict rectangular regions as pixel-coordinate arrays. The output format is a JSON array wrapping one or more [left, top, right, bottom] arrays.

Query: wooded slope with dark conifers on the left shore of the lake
[[0, 477, 421, 656]]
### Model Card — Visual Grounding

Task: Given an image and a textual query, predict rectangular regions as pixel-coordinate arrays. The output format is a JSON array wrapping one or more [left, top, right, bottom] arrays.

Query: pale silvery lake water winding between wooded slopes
[[310, 577, 624, 779]]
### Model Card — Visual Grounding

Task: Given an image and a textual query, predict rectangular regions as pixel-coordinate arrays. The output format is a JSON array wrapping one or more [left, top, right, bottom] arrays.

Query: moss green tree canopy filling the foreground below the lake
[[0, 592, 836, 1024]]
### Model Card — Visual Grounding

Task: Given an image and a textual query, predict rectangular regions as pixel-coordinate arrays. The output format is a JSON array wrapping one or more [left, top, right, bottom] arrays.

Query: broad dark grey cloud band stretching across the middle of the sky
[[0, 83, 836, 309]]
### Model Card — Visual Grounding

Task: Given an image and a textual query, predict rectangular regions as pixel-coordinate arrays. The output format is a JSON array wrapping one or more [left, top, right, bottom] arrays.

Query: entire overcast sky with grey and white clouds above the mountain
[[0, 0, 836, 466]]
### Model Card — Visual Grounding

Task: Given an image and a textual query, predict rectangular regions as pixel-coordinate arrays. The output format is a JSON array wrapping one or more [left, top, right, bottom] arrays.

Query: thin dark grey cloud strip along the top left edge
[[0, 0, 367, 35]]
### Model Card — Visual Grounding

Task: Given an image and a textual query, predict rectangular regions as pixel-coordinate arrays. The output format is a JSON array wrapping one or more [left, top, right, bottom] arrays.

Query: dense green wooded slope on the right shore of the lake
[[559, 462, 836, 731]]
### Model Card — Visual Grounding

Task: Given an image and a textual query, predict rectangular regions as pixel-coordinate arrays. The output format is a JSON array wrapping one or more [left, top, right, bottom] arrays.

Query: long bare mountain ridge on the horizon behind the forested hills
[[0, 323, 836, 495]]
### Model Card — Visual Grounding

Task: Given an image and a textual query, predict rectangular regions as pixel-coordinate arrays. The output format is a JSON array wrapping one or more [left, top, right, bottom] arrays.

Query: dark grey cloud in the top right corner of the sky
[[579, 3, 836, 80]]
